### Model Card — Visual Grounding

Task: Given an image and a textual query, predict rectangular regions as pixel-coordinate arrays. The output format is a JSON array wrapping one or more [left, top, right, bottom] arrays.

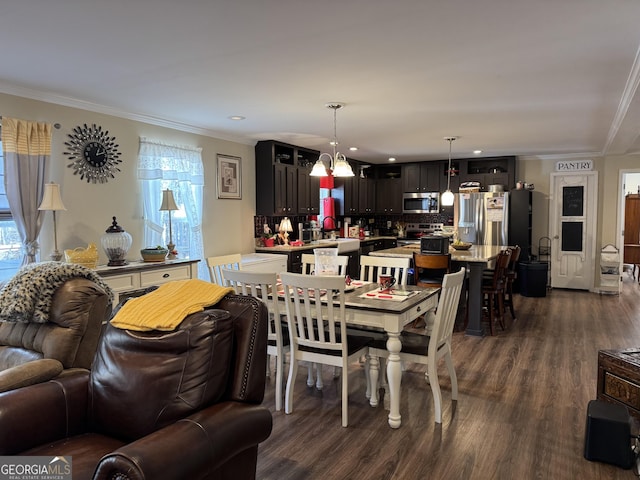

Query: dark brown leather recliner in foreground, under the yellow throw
[[0, 295, 272, 480]]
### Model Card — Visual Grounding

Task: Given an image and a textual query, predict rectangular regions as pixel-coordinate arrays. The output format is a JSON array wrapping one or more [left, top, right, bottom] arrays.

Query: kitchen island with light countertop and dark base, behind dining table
[[369, 245, 507, 336]]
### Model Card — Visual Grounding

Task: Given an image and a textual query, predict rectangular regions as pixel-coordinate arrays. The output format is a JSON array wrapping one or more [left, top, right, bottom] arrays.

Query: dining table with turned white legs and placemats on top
[[279, 281, 440, 428]]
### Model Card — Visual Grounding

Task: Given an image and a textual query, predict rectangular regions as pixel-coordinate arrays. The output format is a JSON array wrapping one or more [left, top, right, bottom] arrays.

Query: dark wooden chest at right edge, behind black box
[[598, 347, 640, 419]]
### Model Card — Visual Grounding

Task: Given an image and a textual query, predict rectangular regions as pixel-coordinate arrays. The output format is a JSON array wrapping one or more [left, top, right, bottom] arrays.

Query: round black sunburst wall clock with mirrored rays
[[64, 123, 122, 183]]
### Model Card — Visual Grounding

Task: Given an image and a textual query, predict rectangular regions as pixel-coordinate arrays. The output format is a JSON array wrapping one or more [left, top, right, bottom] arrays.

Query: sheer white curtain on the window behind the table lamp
[[138, 137, 209, 280]]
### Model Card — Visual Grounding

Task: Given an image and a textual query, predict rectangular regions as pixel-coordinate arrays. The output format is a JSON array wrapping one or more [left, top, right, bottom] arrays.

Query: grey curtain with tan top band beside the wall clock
[[2, 117, 51, 265]]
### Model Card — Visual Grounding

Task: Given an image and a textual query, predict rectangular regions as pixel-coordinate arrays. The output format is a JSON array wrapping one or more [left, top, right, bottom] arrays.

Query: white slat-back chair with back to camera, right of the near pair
[[280, 273, 371, 427]]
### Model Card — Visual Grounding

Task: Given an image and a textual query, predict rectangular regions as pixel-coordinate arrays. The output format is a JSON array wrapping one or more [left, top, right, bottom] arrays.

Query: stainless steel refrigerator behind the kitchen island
[[453, 192, 509, 245]]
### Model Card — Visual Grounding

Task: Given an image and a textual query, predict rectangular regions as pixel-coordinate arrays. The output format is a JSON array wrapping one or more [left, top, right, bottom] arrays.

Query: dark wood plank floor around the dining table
[[257, 273, 640, 480]]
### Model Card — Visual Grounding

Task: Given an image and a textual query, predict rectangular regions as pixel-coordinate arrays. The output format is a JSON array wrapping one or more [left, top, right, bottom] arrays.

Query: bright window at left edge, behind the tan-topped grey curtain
[[0, 141, 22, 282]]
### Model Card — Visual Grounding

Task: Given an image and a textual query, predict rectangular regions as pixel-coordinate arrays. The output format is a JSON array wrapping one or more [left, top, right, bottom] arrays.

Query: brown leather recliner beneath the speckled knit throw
[[0, 277, 111, 392]]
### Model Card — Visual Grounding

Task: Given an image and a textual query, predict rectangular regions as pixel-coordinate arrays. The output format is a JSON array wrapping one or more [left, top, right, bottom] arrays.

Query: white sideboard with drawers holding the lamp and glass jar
[[95, 259, 200, 305]]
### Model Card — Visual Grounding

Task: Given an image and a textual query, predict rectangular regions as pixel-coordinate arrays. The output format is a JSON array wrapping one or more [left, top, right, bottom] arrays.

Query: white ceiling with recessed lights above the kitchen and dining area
[[0, 0, 640, 163]]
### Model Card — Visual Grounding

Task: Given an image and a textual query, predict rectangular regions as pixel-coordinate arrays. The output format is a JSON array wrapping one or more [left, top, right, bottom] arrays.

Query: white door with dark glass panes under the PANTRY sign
[[549, 172, 598, 290]]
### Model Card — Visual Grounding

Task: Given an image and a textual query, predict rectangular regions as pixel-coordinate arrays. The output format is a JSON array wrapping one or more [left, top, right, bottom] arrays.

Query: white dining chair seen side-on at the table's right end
[[369, 268, 465, 423]]
